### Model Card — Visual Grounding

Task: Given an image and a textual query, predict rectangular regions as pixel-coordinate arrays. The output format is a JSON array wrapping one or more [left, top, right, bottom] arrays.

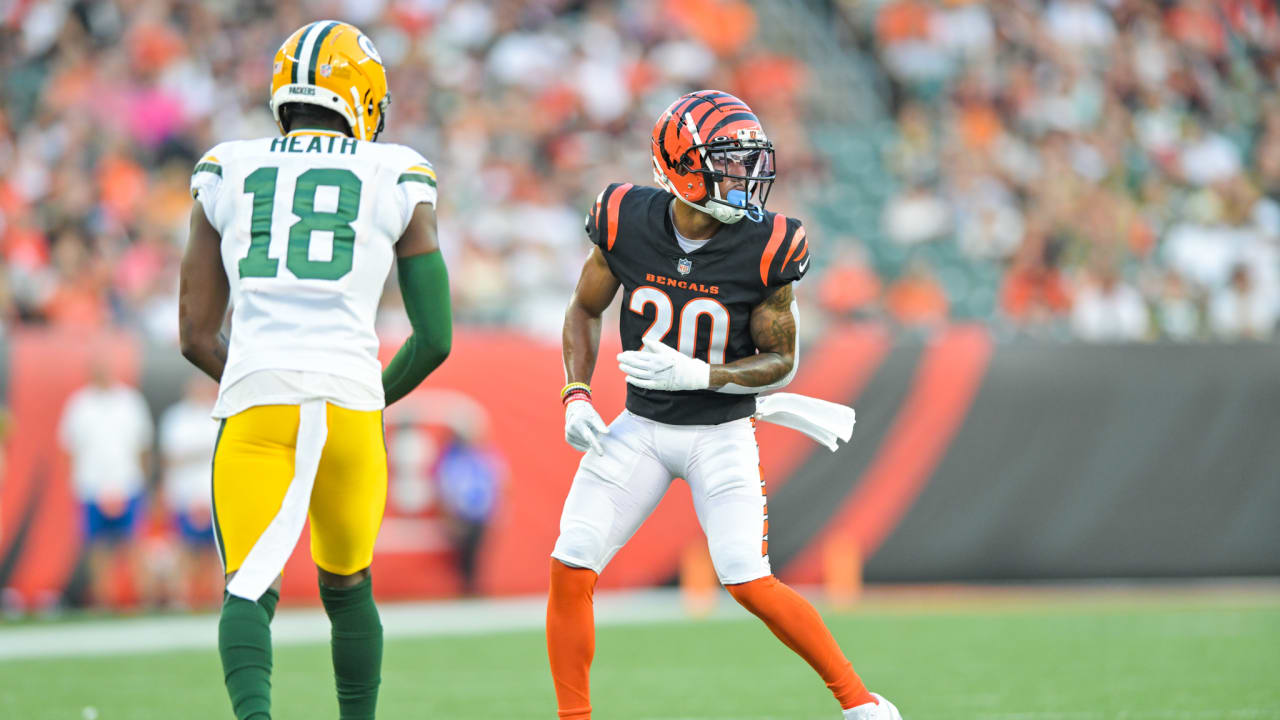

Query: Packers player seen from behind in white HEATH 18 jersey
[[179, 20, 452, 720]]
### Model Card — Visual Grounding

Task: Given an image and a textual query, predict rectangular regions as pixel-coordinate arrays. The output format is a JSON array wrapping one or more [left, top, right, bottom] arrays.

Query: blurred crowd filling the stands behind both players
[[0, 0, 1280, 342]]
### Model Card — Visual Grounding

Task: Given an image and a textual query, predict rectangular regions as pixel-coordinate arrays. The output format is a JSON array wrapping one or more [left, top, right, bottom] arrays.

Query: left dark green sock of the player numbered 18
[[218, 589, 280, 720]]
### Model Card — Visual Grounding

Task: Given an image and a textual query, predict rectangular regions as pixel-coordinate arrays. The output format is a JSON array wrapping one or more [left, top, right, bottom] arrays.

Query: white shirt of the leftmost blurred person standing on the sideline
[[58, 384, 154, 502]]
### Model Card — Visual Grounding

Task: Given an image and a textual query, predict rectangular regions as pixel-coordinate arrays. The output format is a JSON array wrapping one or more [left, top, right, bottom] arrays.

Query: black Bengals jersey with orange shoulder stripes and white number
[[586, 183, 810, 425]]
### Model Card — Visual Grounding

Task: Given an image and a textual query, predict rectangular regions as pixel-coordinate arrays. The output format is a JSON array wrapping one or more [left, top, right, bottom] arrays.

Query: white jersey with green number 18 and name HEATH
[[191, 131, 436, 415]]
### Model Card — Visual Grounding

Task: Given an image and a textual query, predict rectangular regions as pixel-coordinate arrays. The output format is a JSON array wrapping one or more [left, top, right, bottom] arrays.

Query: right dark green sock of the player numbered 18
[[320, 578, 383, 720]]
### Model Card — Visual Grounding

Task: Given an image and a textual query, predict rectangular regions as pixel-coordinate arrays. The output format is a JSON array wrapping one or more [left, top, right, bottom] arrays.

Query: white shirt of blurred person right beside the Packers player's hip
[[160, 400, 218, 514]]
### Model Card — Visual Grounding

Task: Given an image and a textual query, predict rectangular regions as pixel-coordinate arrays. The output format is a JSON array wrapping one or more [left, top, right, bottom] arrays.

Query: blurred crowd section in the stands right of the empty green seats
[[842, 0, 1280, 341]]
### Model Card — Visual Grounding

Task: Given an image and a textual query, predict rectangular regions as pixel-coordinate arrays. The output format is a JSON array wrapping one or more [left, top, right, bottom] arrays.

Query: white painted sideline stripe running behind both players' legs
[[0, 589, 749, 661]]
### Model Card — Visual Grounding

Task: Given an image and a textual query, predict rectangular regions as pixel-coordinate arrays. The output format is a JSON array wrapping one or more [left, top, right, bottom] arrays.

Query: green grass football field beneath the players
[[0, 593, 1280, 720]]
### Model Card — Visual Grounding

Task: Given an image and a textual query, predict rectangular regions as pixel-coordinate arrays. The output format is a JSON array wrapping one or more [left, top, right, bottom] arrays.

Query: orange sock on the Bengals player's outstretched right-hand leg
[[724, 575, 876, 710]]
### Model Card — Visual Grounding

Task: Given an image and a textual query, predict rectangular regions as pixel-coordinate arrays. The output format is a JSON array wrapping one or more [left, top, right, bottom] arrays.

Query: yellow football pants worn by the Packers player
[[214, 404, 387, 575]]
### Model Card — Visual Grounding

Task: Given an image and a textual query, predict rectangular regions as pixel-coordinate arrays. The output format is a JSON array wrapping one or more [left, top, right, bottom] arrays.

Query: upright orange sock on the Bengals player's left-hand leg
[[547, 559, 599, 720]]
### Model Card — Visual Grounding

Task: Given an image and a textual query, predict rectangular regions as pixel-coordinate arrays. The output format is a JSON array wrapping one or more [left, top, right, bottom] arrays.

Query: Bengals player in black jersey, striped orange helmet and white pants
[[547, 90, 901, 720]]
